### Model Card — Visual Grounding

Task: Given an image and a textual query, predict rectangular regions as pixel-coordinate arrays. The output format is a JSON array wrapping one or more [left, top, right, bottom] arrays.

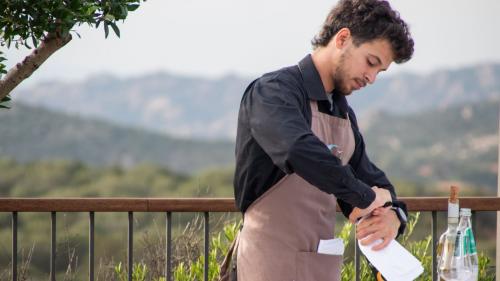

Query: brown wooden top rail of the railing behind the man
[[0, 197, 500, 212]]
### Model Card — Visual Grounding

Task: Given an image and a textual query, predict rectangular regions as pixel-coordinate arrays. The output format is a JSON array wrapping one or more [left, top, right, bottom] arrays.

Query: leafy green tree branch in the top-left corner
[[0, 0, 145, 108]]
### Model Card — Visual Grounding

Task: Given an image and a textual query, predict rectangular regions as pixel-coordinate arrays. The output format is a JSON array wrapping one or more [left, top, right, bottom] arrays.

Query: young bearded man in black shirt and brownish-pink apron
[[234, 0, 413, 281]]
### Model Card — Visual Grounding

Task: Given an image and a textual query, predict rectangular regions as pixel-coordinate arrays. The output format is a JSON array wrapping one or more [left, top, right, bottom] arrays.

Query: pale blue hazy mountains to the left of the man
[[13, 72, 249, 139]]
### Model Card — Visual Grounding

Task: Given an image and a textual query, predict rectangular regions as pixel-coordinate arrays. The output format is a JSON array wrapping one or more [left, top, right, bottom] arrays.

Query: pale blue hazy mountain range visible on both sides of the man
[[13, 64, 500, 140]]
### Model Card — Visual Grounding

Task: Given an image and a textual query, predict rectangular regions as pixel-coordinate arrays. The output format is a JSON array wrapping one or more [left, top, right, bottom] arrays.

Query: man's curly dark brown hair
[[311, 0, 414, 63]]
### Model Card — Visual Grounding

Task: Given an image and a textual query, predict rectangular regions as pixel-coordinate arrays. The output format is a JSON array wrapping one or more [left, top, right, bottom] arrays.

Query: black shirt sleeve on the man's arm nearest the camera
[[242, 74, 375, 208]]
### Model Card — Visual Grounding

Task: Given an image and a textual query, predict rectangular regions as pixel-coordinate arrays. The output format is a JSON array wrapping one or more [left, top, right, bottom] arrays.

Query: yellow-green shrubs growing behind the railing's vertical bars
[[0, 213, 495, 281]]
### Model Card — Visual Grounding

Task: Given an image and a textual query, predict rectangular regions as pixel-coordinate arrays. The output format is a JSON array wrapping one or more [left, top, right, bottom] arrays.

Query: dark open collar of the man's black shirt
[[299, 54, 349, 112]]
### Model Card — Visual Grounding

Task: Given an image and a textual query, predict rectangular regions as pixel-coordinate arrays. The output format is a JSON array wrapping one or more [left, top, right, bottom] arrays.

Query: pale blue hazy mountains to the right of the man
[[349, 64, 500, 116]]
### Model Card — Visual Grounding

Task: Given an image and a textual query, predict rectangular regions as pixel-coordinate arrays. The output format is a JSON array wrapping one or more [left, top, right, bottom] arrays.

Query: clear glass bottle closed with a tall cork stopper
[[437, 186, 472, 281]]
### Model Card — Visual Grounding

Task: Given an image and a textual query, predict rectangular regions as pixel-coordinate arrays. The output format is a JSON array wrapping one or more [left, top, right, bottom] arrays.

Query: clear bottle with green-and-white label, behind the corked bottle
[[458, 208, 478, 281]]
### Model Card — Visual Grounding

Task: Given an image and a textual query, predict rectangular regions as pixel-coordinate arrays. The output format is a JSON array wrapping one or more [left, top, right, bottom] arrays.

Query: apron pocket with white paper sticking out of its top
[[295, 252, 343, 281]]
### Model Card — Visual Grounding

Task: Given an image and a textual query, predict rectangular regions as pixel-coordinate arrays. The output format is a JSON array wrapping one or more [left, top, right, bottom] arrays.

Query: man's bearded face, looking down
[[333, 39, 393, 96]]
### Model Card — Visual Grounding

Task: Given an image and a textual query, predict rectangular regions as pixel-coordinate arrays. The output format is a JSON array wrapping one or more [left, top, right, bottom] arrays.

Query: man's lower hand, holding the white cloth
[[356, 207, 401, 251]]
